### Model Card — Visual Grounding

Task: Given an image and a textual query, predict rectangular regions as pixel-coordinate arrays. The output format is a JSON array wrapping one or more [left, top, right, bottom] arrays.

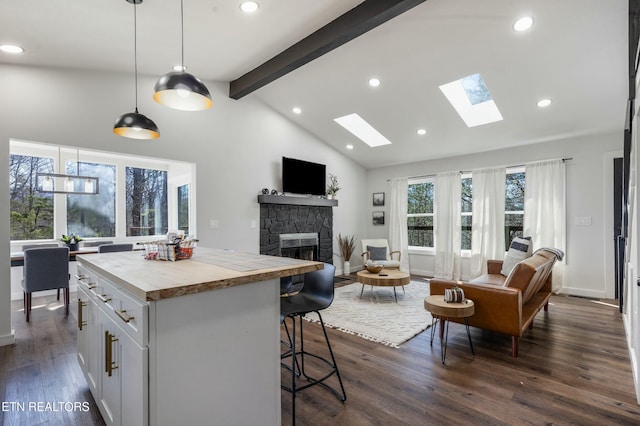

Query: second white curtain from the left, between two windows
[[433, 172, 461, 280]]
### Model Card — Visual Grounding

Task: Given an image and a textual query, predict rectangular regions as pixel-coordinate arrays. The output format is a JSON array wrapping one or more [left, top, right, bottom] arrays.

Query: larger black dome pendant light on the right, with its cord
[[153, 0, 212, 111]]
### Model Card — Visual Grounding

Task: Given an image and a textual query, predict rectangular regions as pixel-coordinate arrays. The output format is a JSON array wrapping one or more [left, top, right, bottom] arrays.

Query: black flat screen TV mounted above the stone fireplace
[[282, 157, 327, 195]]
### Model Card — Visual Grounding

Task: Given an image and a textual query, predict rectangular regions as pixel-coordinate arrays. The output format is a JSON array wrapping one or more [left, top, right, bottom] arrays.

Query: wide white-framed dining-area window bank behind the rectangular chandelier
[[9, 140, 195, 242]]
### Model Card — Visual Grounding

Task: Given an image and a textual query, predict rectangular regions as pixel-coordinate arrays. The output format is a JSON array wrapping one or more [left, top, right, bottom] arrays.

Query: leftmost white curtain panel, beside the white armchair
[[389, 178, 409, 272]]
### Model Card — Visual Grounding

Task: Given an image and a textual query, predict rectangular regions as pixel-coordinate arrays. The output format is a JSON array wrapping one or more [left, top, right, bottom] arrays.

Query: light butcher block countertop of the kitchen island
[[77, 247, 323, 301]]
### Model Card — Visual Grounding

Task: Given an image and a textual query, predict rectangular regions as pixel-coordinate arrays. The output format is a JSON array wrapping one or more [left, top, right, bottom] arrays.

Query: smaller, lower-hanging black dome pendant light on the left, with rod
[[113, 0, 160, 139]]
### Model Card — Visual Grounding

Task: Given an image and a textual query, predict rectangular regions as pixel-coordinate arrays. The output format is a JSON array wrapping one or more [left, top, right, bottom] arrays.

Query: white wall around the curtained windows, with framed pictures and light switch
[[365, 131, 623, 297]]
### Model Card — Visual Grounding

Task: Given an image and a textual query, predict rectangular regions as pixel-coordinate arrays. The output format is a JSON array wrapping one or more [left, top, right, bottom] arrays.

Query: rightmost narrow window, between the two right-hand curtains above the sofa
[[504, 168, 525, 251]]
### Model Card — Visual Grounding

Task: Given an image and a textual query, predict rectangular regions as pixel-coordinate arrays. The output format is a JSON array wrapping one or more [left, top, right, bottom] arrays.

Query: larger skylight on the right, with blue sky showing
[[440, 74, 502, 127]]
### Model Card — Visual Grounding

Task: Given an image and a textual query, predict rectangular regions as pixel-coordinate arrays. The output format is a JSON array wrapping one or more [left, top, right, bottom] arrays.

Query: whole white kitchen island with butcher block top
[[77, 248, 322, 425]]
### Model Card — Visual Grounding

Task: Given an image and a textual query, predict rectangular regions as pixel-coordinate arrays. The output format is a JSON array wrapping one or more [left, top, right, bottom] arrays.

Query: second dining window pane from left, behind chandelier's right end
[[66, 161, 116, 238]]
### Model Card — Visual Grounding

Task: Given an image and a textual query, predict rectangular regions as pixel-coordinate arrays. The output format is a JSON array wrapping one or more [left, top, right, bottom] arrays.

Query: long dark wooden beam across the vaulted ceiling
[[229, 0, 426, 99]]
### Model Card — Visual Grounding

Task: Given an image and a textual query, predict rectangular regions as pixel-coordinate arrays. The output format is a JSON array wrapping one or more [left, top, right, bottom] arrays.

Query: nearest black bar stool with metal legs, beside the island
[[280, 263, 347, 424]]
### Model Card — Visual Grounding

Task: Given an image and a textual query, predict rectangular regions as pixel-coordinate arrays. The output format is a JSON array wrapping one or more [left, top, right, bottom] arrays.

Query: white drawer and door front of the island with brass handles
[[77, 266, 149, 426]]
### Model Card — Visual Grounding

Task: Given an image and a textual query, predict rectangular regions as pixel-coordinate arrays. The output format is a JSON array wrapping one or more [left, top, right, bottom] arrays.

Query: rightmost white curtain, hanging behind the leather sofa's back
[[524, 160, 566, 292]]
